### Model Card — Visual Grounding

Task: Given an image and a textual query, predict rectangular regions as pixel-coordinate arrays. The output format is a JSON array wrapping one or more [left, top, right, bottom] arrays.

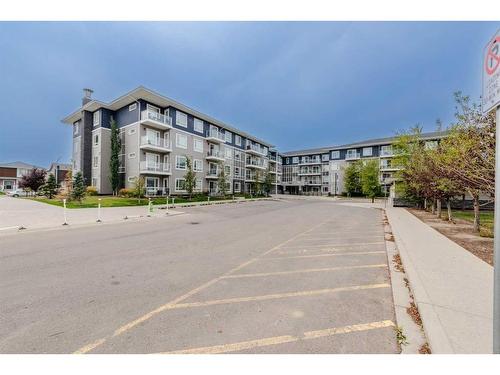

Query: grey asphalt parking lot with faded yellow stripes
[[0, 200, 398, 353]]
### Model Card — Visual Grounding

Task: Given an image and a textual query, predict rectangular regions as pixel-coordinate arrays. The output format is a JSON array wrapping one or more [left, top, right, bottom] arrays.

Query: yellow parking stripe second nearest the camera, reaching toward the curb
[[170, 284, 390, 309]]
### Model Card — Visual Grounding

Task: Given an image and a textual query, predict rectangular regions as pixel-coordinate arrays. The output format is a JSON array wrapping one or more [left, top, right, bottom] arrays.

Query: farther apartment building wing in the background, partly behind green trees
[[282, 132, 446, 195]]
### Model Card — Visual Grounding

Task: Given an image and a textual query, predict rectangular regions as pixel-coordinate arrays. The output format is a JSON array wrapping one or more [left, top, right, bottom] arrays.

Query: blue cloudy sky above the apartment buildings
[[0, 22, 500, 166]]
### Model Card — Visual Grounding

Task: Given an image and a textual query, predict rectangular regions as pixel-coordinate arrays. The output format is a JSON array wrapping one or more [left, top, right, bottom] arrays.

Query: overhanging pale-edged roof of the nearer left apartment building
[[61, 86, 274, 148]]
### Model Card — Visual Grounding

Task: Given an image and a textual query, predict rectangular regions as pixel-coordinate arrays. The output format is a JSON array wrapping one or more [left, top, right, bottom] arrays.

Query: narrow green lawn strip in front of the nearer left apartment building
[[27, 195, 254, 208]]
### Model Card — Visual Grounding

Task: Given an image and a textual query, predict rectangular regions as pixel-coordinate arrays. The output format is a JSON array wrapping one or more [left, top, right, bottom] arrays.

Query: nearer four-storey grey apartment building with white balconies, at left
[[63, 87, 279, 195]]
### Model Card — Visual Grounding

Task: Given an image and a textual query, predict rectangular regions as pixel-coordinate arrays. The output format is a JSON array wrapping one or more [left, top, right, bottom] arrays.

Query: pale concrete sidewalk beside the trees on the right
[[386, 207, 493, 354]]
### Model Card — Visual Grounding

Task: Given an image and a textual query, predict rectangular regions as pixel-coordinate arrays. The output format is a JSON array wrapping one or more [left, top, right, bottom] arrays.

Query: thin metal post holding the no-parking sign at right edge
[[493, 106, 500, 354]]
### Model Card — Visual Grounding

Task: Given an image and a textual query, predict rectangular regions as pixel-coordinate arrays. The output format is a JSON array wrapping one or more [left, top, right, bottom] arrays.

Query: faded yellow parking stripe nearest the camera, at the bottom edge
[[161, 320, 395, 354]]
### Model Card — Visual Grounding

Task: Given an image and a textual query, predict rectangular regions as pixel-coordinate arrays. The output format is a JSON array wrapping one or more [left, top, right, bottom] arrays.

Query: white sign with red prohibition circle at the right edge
[[482, 30, 500, 113]]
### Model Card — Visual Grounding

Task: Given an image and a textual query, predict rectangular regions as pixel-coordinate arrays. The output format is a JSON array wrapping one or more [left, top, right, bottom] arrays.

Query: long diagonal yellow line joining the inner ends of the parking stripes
[[74, 221, 328, 354]]
